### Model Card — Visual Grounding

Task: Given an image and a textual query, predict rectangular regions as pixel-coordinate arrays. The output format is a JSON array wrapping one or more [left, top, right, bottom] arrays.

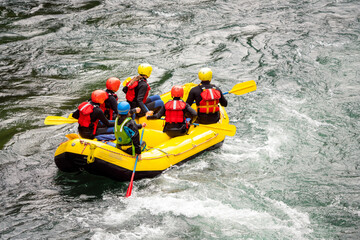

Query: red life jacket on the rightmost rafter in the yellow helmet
[[198, 87, 221, 113]]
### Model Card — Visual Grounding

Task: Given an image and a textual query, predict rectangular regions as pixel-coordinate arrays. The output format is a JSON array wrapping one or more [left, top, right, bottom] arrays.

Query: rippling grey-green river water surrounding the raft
[[0, 0, 360, 240]]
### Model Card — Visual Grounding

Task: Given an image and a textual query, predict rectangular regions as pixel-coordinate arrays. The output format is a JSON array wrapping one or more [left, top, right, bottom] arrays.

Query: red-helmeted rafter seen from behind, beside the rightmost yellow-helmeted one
[[147, 86, 197, 137]]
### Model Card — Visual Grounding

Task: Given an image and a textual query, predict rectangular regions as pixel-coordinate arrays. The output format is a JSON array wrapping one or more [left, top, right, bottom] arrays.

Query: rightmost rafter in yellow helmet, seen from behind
[[186, 68, 227, 124]]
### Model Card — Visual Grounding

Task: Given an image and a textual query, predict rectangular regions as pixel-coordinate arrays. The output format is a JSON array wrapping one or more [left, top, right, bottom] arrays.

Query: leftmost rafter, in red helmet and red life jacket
[[72, 90, 114, 139]]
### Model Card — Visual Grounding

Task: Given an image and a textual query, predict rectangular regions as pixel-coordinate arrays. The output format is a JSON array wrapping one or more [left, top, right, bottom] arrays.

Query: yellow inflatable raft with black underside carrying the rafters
[[55, 83, 236, 181]]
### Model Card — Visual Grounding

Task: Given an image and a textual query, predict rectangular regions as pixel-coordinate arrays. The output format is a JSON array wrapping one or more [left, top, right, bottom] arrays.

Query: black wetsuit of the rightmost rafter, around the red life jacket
[[186, 81, 227, 124]]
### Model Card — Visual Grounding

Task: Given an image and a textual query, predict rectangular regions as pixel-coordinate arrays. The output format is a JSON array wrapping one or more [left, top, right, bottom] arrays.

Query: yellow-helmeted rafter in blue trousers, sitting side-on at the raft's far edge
[[123, 63, 164, 117]]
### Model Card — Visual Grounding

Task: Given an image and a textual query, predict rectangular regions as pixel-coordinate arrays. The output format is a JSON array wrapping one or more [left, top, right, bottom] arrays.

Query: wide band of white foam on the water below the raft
[[94, 195, 311, 239]]
